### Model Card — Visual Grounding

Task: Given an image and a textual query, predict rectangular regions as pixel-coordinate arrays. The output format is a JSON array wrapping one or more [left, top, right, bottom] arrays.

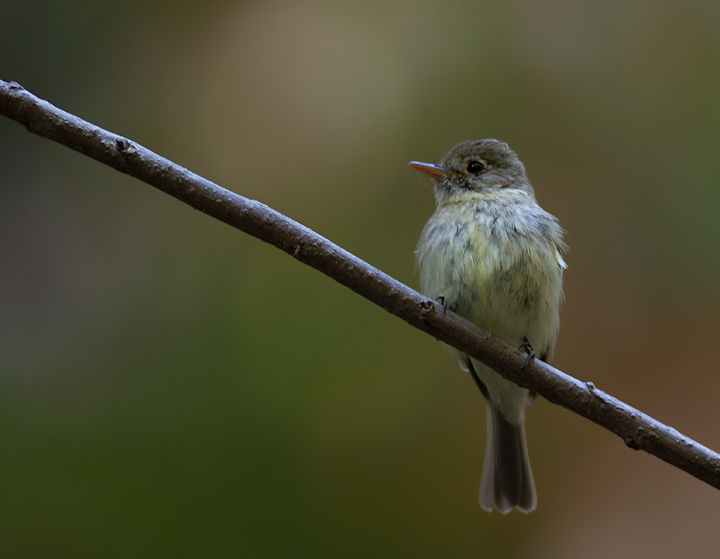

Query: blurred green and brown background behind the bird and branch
[[0, 0, 720, 558]]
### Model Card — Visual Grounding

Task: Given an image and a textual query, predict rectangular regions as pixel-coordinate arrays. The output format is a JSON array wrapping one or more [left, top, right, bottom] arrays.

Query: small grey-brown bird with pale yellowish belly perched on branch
[[410, 139, 567, 514]]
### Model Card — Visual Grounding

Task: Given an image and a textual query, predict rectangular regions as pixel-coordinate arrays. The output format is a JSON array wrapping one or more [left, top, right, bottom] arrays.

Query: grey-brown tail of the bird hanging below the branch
[[480, 400, 537, 514]]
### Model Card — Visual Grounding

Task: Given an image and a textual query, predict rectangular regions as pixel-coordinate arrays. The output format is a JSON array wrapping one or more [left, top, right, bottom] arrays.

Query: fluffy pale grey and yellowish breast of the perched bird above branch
[[417, 204, 564, 355]]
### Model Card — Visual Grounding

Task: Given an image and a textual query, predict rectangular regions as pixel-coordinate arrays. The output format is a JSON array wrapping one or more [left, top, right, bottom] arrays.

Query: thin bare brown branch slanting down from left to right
[[0, 80, 720, 489]]
